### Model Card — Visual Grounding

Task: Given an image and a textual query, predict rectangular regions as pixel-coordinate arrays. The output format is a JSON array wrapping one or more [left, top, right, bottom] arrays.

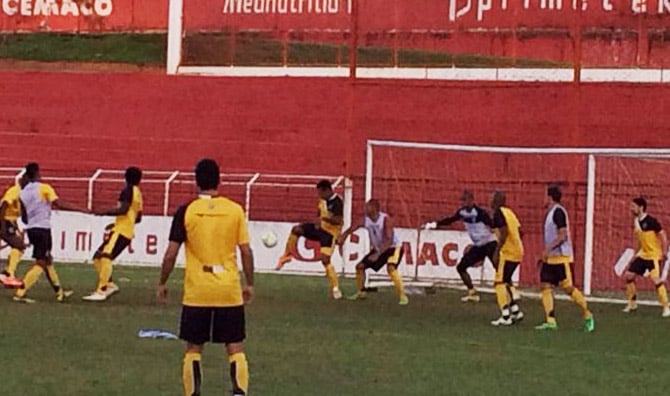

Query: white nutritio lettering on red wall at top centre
[[223, 0, 352, 14]]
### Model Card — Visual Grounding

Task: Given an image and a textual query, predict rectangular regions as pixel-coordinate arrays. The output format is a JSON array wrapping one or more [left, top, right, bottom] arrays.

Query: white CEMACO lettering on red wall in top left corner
[[2, 0, 114, 17]]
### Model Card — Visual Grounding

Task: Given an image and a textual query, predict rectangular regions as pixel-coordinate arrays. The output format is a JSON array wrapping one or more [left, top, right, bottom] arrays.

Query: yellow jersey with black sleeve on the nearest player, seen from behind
[[170, 195, 249, 307]]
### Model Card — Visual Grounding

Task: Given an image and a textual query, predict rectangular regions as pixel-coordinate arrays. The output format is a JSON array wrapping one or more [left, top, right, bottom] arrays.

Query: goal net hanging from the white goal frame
[[366, 141, 670, 294]]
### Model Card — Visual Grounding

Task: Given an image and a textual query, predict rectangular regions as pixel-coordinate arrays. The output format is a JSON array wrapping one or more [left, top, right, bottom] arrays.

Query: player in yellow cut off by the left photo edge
[[0, 178, 25, 287]]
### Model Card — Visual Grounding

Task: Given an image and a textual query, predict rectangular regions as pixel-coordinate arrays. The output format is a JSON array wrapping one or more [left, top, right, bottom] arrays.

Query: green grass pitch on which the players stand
[[0, 265, 670, 396]]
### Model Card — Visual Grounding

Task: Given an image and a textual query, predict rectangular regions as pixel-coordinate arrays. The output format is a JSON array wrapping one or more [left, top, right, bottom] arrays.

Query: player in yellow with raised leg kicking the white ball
[[277, 180, 344, 300]]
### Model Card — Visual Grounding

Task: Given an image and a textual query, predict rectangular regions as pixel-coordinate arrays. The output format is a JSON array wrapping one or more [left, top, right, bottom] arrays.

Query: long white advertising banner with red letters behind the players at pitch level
[[3, 211, 510, 281]]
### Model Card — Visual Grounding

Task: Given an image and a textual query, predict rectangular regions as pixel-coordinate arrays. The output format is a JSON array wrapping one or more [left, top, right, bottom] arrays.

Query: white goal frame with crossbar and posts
[[365, 140, 670, 295]]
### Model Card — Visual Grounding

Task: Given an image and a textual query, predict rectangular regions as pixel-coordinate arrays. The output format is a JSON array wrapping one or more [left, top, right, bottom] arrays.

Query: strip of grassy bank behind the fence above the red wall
[[0, 33, 569, 67]]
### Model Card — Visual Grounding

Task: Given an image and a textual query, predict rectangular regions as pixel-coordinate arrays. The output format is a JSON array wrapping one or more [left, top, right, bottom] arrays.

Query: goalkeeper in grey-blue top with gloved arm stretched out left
[[424, 190, 498, 302]]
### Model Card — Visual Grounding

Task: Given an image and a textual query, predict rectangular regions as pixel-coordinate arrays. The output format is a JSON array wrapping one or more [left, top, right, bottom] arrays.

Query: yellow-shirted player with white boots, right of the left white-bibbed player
[[82, 166, 142, 301]]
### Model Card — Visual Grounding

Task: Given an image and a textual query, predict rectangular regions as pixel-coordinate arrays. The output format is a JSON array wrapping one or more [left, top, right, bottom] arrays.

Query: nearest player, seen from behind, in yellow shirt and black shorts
[[157, 159, 254, 396]]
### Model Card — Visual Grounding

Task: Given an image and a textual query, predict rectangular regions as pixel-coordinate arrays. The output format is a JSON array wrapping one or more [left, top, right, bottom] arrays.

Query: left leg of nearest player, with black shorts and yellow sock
[[179, 306, 213, 396]]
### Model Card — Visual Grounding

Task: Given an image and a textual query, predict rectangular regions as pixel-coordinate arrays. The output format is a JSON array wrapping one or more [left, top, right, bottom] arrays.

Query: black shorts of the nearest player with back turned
[[179, 305, 246, 345]]
